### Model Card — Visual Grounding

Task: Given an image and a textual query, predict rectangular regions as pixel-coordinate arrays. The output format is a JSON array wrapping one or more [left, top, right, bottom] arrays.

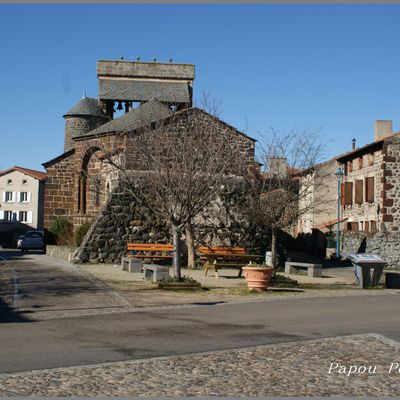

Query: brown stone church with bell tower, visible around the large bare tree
[[43, 60, 255, 255]]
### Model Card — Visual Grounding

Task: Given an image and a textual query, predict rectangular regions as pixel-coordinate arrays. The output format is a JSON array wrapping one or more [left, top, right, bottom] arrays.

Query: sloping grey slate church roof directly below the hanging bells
[[74, 99, 173, 140]]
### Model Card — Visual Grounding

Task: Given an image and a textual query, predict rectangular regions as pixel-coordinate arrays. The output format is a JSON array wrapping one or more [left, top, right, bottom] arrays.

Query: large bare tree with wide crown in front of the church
[[99, 108, 248, 280]]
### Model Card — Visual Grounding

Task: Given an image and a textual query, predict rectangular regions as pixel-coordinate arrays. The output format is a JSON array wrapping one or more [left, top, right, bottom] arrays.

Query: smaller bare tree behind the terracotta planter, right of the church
[[248, 130, 325, 271]]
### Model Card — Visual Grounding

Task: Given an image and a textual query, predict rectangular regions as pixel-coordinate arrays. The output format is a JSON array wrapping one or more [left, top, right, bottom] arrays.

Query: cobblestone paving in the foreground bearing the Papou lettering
[[0, 335, 400, 396]]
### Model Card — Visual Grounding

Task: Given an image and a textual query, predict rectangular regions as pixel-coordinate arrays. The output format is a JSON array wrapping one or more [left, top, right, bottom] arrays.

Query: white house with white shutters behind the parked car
[[0, 167, 46, 229]]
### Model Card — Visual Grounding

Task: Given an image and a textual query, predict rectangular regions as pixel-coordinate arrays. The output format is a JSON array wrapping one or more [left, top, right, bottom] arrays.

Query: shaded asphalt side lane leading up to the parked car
[[0, 250, 128, 317]]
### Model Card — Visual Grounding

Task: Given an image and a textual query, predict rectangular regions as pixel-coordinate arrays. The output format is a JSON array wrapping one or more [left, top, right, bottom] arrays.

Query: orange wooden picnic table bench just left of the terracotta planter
[[197, 246, 262, 278]]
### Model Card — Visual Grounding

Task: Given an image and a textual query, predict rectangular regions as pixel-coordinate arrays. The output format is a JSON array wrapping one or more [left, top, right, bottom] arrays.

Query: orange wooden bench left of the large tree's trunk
[[121, 243, 174, 272]]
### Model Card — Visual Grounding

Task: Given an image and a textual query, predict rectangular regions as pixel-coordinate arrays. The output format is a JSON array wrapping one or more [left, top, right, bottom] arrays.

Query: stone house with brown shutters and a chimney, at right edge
[[337, 120, 400, 233]]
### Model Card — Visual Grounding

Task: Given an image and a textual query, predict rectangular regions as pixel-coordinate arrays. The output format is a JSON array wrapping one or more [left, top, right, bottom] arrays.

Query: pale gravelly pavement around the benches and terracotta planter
[[77, 264, 399, 307]]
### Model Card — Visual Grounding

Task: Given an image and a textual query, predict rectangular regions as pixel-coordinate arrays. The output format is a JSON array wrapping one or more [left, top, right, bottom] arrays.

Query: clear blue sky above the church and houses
[[0, 4, 400, 170]]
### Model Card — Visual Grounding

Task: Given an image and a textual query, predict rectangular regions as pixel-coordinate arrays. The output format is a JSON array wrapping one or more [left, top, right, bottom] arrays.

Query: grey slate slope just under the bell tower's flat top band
[[99, 78, 191, 103]]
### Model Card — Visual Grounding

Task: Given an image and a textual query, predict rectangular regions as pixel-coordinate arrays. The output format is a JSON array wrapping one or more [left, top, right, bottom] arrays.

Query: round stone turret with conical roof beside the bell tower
[[63, 95, 110, 152]]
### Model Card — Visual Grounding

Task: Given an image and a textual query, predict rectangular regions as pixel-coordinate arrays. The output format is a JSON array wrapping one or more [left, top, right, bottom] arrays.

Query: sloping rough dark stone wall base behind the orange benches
[[74, 182, 268, 263]]
